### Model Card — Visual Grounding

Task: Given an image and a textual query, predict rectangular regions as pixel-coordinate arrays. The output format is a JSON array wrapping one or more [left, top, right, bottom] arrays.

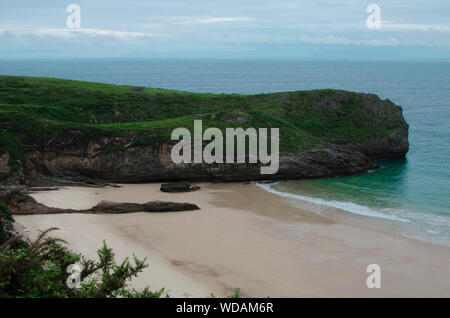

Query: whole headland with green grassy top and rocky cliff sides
[[0, 76, 409, 184]]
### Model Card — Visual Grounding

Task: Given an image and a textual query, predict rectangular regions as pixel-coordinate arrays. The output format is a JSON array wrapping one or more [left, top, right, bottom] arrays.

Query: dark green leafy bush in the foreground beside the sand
[[0, 228, 164, 298]]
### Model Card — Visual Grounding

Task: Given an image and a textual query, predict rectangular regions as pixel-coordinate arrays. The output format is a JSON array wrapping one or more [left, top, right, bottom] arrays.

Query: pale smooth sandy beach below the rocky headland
[[15, 183, 450, 297]]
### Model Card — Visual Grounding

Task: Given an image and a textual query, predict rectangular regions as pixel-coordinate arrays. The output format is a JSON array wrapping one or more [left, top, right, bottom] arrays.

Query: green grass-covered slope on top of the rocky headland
[[0, 76, 406, 181]]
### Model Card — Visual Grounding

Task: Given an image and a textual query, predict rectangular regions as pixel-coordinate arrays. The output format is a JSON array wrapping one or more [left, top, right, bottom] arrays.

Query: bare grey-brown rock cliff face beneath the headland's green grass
[[20, 131, 400, 182]]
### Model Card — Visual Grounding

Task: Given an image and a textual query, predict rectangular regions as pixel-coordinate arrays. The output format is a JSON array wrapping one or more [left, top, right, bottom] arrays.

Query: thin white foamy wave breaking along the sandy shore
[[256, 183, 411, 223]]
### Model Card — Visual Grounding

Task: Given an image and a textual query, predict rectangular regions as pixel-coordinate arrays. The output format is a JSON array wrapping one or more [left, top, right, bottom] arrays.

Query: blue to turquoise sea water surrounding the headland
[[0, 59, 450, 245]]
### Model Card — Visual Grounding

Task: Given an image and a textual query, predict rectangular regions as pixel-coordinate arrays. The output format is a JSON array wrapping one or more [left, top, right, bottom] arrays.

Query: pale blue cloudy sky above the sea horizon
[[0, 0, 450, 59]]
